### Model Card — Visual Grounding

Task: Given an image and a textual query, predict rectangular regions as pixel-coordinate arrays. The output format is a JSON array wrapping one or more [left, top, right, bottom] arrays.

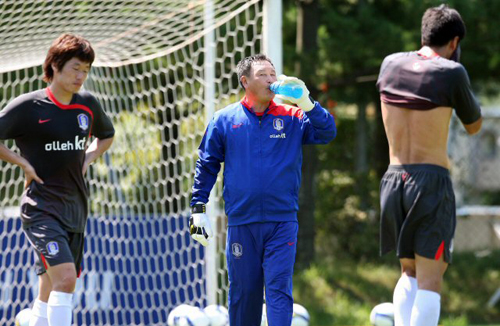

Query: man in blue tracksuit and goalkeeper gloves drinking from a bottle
[[191, 54, 336, 326]]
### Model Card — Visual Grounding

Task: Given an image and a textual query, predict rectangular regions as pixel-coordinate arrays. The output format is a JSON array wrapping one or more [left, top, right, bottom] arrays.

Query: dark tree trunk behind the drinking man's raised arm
[[295, 0, 319, 270]]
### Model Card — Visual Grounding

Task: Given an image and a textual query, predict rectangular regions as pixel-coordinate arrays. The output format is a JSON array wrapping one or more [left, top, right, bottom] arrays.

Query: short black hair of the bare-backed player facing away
[[422, 4, 466, 46]]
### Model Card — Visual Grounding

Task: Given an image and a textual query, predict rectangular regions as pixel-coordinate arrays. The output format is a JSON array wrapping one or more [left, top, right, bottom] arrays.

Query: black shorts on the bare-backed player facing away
[[380, 164, 456, 263]]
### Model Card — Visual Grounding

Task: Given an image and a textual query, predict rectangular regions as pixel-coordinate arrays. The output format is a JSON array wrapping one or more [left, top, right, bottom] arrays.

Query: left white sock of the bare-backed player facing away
[[392, 274, 418, 326]]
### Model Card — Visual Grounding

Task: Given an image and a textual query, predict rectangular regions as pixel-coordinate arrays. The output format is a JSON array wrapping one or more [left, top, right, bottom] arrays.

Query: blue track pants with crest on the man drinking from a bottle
[[226, 222, 298, 326]]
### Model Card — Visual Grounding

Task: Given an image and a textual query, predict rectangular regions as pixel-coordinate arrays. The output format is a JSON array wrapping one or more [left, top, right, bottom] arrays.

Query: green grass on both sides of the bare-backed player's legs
[[294, 251, 500, 326]]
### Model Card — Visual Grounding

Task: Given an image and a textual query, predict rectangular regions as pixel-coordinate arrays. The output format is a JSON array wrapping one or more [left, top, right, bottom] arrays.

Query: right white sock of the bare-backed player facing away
[[411, 290, 441, 326]]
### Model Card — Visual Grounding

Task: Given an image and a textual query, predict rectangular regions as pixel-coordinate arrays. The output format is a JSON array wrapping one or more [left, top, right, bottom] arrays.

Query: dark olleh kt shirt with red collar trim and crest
[[0, 88, 115, 232]]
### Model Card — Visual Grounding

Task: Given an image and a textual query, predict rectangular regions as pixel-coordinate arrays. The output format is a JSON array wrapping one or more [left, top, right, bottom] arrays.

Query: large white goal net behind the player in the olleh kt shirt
[[0, 0, 263, 325]]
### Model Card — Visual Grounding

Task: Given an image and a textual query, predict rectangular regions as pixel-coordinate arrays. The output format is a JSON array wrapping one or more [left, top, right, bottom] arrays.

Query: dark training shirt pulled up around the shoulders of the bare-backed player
[[377, 52, 481, 124]]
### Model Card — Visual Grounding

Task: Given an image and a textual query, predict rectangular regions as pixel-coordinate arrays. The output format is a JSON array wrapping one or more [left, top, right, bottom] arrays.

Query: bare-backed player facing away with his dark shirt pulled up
[[377, 5, 482, 326]]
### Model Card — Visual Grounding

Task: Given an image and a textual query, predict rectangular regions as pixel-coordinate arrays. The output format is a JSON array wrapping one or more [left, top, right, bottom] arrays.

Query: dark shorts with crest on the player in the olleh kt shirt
[[24, 220, 85, 276]]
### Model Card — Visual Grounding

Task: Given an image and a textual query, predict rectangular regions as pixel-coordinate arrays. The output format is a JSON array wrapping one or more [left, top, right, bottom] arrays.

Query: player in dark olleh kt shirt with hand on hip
[[0, 34, 114, 326]]
